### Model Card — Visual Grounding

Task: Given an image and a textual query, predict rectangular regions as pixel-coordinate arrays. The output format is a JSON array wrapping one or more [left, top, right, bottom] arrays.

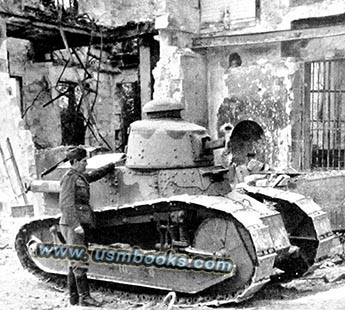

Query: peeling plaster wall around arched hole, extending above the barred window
[[207, 31, 345, 169]]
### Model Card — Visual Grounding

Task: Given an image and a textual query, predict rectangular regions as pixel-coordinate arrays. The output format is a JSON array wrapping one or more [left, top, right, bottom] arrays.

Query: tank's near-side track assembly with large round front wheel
[[16, 195, 284, 303]]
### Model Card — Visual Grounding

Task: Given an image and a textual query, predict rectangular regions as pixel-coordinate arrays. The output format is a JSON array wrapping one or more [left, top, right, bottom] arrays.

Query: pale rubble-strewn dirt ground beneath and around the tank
[[0, 219, 345, 310]]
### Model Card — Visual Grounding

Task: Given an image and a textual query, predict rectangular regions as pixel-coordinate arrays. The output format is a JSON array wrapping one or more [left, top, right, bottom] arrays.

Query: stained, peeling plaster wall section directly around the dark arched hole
[[207, 43, 298, 168]]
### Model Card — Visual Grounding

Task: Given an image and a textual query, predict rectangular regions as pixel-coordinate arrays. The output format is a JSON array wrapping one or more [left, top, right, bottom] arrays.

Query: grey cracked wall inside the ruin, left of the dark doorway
[[8, 38, 61, 149]]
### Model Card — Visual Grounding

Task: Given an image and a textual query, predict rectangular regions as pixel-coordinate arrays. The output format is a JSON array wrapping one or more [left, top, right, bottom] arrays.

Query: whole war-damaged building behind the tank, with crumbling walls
[[0, 0, 345, 228]]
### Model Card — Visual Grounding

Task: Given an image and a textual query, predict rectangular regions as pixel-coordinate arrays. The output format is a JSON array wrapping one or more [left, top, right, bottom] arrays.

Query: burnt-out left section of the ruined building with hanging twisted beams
[[1, 1, 159, 211]]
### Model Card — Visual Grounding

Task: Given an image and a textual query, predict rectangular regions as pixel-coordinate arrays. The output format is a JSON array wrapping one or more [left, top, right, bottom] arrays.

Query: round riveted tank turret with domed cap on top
[[126, 99, 214, 169]]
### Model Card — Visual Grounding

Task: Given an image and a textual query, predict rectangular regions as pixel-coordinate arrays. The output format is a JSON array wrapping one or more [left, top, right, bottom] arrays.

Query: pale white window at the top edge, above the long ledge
[[201, 0, 260, 29]]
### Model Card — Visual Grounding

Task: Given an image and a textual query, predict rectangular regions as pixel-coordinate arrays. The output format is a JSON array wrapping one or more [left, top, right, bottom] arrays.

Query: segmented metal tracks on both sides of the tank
[[15, 188, 335, 307]]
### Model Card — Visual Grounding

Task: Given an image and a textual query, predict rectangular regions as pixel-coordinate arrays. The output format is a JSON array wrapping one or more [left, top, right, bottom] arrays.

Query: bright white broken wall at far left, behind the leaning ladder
[[0, 35, 41, 214]]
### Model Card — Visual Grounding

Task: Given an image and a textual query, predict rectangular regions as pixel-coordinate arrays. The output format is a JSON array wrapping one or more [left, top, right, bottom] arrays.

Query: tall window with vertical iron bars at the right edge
[[303, 59, 345, 170]]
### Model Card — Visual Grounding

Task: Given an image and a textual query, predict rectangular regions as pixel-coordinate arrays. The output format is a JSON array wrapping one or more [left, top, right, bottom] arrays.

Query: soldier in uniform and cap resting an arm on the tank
[[59, 147, 115, 307]]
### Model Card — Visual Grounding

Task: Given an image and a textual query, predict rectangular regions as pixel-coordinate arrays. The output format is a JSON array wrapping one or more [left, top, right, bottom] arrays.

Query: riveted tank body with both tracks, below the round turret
[[16, 166, 338, 304]]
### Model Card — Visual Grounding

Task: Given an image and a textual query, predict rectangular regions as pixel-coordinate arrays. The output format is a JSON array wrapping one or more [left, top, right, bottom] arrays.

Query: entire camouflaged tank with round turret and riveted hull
[[16, 99, 338, 305]]
